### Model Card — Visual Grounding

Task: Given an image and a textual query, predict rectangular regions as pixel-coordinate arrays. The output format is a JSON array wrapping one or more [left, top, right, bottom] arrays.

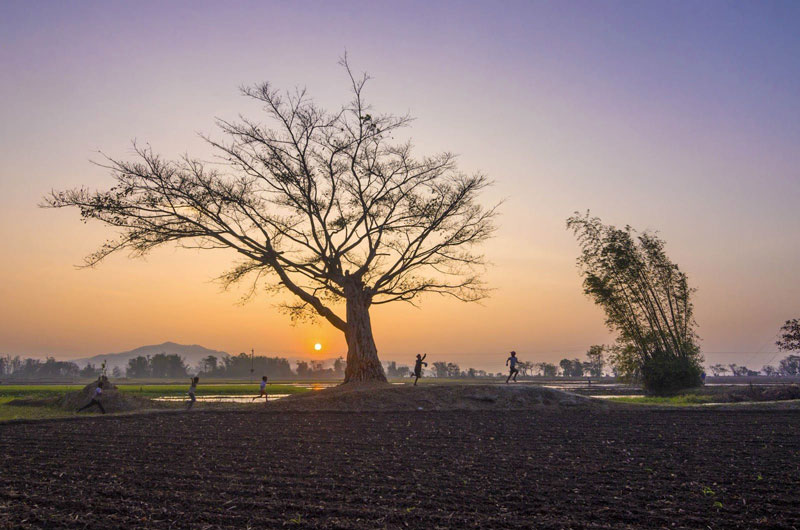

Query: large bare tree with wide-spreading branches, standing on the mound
[[45, 58, 496, 382]]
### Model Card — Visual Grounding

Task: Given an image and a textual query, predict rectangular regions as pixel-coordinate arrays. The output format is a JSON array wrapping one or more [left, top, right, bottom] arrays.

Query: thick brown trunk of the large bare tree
[[344, 285, 386, 383]]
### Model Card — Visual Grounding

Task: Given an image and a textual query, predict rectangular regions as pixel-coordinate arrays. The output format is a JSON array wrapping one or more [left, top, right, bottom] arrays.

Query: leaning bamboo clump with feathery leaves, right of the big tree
[[567, 213, 702, 392]]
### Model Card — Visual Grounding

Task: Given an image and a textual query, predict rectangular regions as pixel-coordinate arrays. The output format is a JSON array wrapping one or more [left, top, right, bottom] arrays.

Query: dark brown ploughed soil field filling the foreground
[[0, 407, 800, 529]]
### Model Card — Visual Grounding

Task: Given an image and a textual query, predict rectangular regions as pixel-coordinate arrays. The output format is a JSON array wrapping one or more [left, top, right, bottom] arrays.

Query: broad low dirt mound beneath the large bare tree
[[269, 383, 607, 412]]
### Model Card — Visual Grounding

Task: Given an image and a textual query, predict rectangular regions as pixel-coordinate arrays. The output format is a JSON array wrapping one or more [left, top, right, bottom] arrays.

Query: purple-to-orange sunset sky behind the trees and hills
[[0, 0, 800, 370]]
